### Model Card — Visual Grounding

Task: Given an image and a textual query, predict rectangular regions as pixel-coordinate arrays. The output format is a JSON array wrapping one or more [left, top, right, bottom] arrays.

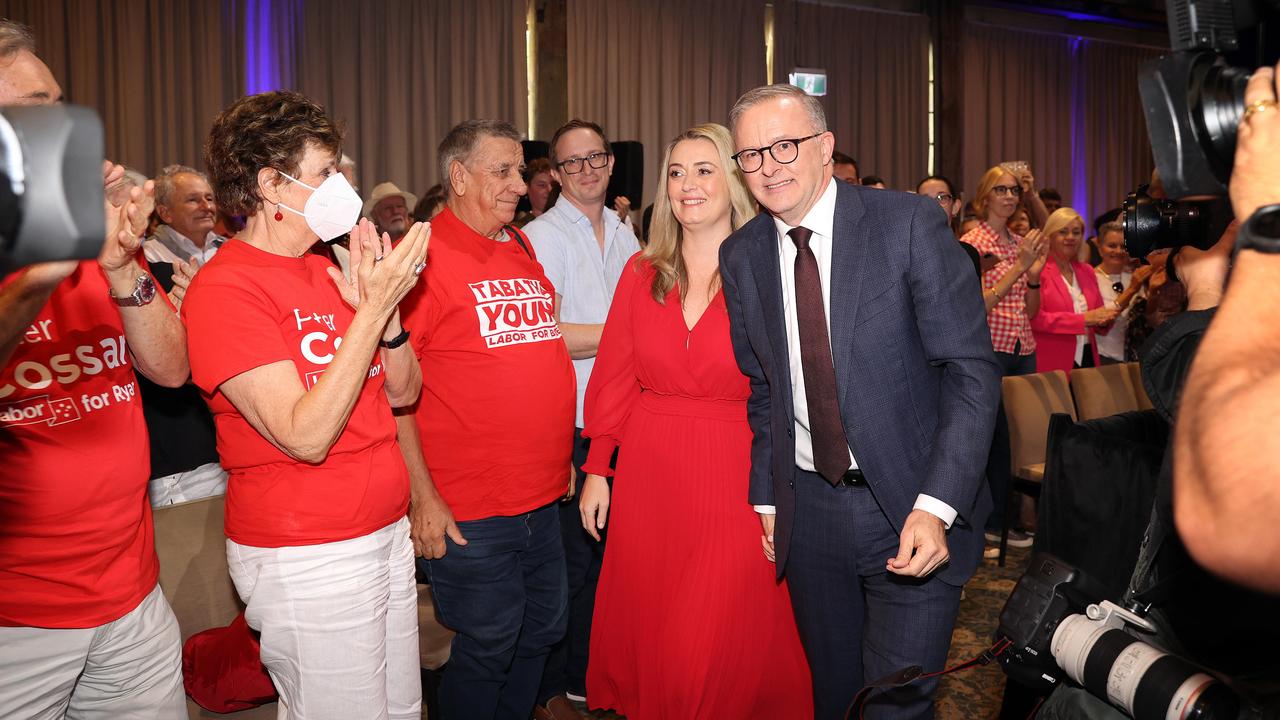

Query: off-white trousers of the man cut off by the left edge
[[0, 585, 187, 720]]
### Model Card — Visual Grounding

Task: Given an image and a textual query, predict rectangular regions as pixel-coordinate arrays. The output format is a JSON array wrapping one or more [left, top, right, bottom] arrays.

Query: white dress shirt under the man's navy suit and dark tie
[[755, 179, 956, 528]]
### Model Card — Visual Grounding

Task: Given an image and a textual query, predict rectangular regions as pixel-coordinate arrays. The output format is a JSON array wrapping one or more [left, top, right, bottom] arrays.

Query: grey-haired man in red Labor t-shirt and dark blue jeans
[[397, 120, 575, 720]]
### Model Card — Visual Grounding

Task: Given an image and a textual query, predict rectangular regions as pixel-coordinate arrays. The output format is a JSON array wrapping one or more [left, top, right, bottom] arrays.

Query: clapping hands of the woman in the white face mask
[[329, 218, 431, 313]]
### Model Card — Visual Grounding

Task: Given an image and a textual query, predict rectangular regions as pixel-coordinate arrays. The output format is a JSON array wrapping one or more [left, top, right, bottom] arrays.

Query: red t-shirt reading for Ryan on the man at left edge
[[0, 260, 163, 628]]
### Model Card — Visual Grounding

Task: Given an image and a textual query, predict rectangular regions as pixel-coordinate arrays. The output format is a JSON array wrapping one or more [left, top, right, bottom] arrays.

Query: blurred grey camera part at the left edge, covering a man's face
[[0, 105, 106, 277]]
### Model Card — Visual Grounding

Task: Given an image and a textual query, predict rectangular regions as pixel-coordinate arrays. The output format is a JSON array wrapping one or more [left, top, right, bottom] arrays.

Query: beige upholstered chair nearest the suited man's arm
[[1000, 370, 1079, 565]]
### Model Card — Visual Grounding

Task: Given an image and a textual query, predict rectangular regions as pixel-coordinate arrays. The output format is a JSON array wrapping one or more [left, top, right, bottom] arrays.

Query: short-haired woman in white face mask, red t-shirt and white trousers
[[182, 92, 430, 719]]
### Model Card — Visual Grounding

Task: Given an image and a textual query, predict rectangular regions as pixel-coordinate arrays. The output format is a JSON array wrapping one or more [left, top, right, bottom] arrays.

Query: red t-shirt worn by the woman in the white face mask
[[182, 240, 408, 547]]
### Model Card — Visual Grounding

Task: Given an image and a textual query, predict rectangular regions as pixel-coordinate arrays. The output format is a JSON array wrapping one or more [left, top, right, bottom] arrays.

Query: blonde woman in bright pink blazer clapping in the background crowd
[[1032, 208, 1117, 373]]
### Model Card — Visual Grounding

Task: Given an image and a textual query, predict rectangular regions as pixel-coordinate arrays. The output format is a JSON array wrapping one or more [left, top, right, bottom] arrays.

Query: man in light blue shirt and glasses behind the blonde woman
[[525, 119, 640, 720]]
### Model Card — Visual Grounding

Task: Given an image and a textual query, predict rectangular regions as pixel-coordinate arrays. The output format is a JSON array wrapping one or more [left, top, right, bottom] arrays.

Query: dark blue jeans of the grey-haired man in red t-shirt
[[419, 503, 568, 720]]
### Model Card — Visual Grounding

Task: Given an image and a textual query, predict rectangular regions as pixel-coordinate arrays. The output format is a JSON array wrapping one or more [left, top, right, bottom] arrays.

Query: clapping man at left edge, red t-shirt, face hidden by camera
[[0, 20, 188, 717]]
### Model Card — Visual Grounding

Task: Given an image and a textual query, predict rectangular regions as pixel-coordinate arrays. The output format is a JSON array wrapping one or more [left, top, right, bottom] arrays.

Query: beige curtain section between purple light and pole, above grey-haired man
[[294, 0, 529, 195]]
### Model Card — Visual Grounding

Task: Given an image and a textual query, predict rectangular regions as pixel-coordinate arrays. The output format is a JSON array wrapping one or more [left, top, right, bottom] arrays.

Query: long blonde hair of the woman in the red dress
[[643, 123, 756, 305]]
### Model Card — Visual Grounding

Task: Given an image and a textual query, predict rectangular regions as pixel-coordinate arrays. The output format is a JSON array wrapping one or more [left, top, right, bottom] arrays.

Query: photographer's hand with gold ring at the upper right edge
[[1231, 61, 1280, 222]]
